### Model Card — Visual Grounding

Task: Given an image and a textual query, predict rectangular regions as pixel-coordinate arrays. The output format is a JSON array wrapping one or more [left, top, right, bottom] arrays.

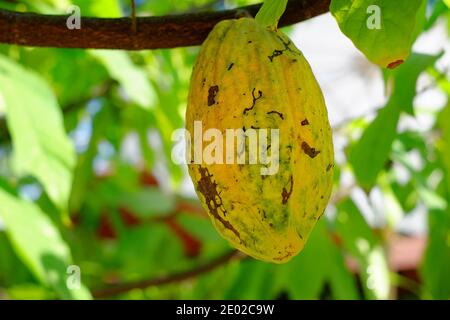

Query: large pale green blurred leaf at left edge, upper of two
[[0, 56, 75, 211]]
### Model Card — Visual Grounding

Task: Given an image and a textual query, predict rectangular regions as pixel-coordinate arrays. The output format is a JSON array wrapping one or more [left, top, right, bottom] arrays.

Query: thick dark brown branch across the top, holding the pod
[[0, 0, 330, 50]]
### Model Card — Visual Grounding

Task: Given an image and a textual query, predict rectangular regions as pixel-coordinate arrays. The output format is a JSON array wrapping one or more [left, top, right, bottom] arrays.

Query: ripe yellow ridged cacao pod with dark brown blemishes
[[186, 18, 334, 263]]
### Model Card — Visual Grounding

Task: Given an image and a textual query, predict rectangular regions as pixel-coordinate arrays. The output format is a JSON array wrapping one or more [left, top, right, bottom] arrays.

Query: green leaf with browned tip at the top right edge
[[330, 0, 426, 68]]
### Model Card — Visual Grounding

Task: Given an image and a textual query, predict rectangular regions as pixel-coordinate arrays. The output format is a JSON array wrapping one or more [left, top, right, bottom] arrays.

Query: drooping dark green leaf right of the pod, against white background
[[349, 54, 440, 190]]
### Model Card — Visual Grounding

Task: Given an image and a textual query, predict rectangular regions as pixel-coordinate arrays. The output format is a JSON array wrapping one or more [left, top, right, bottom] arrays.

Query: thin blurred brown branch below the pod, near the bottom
[[92, 250, 246, 299]]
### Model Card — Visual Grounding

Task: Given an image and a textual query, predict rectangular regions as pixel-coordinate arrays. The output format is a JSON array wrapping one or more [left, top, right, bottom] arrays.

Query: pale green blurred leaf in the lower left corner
[[0, 189, 91, 299]]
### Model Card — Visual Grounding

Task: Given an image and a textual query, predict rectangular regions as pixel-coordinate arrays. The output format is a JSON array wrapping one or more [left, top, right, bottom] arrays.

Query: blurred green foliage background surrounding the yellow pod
[[0, 0, 450, 299]]
